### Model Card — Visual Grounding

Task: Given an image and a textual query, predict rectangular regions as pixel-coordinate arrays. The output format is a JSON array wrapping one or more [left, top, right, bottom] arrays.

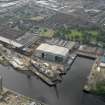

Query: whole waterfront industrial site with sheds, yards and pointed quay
[[0, 25, 77, 85]]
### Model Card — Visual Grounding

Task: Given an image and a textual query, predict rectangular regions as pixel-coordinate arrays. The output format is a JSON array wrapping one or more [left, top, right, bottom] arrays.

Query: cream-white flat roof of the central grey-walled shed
[[36, 43, 69, 56]]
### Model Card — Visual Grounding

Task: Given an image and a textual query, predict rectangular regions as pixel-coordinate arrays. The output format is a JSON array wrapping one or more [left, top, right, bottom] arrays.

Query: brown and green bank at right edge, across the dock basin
[[84, 57, 105, 97]]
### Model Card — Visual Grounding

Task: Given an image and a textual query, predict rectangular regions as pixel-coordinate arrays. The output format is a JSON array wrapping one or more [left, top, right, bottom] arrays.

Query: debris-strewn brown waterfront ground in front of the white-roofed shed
[[0, 45, 76, 86]]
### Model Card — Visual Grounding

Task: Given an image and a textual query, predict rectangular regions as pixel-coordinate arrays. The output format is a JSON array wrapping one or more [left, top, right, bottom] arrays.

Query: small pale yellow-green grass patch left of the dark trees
[[39, 28, 54, 38]]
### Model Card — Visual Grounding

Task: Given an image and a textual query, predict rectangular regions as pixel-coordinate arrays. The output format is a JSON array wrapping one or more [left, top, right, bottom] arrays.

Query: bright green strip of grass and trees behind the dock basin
[[54, 27, 105, 43]]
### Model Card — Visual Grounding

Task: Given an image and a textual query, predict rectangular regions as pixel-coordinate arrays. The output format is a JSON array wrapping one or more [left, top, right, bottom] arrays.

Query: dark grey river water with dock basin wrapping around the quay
[[0, 57, 105, 105]]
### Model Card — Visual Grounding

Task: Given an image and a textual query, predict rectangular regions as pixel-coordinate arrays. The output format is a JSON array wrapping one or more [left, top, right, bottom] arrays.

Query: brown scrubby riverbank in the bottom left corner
[[0, 88, 46, 105]]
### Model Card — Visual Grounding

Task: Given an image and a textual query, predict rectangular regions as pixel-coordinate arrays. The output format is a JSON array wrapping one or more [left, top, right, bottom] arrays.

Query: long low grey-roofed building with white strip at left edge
[[0, 26, 39, 48]]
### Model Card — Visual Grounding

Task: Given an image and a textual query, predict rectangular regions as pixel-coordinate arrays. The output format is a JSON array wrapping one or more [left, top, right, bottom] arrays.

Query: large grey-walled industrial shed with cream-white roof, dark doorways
[[34, 43, 69, 63]]
